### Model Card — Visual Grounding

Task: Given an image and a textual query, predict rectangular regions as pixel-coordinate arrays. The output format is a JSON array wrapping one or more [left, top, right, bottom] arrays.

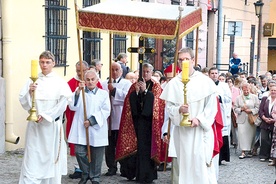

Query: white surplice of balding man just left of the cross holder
[[102, 78, 132, 130]]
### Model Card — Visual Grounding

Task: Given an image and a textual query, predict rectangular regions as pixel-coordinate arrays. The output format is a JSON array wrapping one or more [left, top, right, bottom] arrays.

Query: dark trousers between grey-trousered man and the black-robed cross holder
[[105, 130, 119, 172]]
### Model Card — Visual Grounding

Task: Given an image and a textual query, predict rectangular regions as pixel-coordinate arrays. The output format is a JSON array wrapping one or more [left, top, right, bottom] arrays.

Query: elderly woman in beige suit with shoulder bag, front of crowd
[[234, 82, 259, 159]]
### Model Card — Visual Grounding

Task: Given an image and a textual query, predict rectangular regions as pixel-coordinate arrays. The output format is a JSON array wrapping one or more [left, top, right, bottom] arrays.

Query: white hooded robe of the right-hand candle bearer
[[160, 71, 217, 184]]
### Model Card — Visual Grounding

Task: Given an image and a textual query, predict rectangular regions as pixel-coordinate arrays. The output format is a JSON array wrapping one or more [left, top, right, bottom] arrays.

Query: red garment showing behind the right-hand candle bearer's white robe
[[212, 98, 223, 157]]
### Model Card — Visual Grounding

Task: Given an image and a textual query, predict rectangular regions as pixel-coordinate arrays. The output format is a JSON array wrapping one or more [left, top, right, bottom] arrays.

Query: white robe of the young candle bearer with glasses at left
[[19, 72, 72, 184]]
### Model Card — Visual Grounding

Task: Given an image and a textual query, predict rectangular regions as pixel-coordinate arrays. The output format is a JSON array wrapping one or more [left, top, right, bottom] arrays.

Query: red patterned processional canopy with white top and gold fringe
[[77, 0, 202, 39]]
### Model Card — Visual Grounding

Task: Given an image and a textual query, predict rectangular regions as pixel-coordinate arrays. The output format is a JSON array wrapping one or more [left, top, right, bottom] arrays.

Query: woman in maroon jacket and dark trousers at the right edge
[[259, 86, 276, 162]]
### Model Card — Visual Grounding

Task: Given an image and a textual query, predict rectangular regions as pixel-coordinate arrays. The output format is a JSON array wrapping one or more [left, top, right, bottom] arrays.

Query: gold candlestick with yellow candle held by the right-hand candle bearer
[[180, 60, 191, 126]]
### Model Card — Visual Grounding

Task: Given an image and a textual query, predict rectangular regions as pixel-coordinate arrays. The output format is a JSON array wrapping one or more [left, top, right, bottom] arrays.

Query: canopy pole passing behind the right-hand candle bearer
[[164, 6, 184, 171]]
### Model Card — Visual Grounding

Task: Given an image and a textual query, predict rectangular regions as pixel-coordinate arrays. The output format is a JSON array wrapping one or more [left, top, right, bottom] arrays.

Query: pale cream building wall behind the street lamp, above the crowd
[[216, 0, 269, 75]]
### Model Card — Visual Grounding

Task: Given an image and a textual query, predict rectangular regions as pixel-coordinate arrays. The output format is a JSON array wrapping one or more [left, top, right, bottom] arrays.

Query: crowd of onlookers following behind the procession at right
[[213, 68, 276, 166]]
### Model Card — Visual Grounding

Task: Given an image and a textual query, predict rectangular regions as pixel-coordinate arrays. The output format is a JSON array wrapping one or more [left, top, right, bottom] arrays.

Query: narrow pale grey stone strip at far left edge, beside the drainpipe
[[0, 77, 6, 154]]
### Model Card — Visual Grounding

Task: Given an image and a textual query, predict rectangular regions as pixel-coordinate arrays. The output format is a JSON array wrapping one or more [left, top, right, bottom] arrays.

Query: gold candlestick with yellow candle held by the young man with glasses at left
[[27, 60, 38, 122]]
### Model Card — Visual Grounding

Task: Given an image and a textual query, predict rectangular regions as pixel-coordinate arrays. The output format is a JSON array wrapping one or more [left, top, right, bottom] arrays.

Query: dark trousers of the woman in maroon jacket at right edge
[[259, 129, 273, 159]]
